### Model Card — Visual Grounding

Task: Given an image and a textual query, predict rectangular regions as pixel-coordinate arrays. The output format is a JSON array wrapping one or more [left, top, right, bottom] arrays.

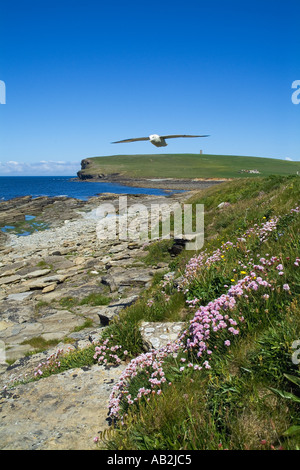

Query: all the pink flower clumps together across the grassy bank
[[106, 207, 300, 419]]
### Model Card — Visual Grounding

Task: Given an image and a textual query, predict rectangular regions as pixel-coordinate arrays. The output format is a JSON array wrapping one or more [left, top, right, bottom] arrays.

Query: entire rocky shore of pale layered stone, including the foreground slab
[[0, 189, 197, 449]]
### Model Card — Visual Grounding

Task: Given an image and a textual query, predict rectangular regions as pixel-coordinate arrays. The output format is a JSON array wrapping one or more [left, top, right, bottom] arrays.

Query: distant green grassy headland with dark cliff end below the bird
[[81, 154, 300, 179]]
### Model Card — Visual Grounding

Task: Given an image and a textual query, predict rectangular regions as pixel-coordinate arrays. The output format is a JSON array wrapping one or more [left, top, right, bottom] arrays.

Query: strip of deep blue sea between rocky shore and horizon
[[0, 176, 173, 201]]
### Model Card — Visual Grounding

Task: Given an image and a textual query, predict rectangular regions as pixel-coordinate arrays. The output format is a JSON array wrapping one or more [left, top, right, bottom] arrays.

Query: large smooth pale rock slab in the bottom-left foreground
[[0, 365, 125, 450]]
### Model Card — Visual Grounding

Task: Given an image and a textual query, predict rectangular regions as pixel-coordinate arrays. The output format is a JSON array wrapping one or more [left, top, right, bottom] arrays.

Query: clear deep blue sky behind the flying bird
[[0, 0, 300, 175]]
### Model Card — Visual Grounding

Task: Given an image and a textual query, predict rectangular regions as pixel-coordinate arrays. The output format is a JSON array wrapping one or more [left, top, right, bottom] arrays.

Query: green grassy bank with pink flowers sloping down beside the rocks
[[17, 172, 300, 450]]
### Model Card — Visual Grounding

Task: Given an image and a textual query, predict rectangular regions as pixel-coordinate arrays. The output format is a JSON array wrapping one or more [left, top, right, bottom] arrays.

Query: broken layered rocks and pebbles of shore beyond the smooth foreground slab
[[0, 193, 192, 360]]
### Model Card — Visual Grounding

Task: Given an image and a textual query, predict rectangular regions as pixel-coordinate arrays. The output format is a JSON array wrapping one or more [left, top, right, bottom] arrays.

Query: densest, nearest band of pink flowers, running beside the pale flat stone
[[109, 264, 272, 417]]
